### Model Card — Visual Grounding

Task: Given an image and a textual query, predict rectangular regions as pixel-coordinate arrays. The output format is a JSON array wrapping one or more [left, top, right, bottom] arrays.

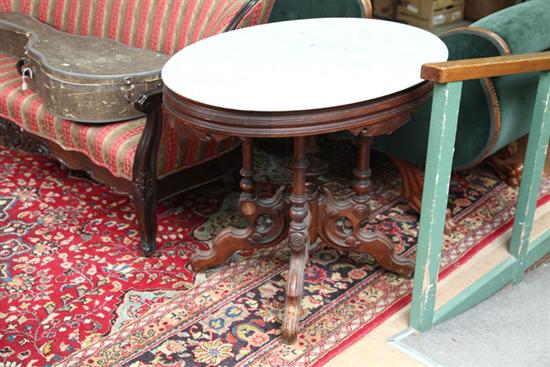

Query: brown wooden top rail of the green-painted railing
[[421, 51, 550, 83]]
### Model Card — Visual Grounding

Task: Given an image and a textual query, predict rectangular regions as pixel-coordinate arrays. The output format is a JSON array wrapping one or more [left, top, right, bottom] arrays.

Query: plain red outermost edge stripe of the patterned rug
[[310, 193, 550, 367]]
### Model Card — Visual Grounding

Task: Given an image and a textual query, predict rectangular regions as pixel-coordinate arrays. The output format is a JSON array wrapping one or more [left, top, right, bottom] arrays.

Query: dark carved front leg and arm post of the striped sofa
[[132, 89, 162, 256]]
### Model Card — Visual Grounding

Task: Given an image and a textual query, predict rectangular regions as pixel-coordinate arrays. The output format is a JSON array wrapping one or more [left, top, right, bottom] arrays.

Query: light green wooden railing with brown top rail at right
[[410, 52, 550, 331]]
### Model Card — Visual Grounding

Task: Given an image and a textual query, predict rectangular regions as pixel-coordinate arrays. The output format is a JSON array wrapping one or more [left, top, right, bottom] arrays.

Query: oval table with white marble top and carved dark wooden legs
[[162, 18, 447, 343]]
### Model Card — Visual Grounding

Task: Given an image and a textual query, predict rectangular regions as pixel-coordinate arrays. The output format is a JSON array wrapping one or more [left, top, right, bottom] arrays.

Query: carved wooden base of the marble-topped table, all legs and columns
[[191, 133, 414, 344]]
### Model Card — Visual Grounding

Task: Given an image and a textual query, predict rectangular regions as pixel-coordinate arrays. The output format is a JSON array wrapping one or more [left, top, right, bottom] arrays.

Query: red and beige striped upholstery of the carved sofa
[[0, 0, 274, 180]]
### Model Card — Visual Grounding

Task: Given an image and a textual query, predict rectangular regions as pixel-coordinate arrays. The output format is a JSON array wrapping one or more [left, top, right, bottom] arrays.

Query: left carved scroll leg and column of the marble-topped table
[[191, 138, 288, 271]]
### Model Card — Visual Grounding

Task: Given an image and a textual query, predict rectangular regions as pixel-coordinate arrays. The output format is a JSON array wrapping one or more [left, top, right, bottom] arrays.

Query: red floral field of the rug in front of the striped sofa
[[0, 147, 215, 367]]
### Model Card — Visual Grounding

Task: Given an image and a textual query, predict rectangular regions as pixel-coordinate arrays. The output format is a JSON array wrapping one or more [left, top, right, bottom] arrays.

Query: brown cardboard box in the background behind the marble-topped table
[[397, 0, 464, 28]]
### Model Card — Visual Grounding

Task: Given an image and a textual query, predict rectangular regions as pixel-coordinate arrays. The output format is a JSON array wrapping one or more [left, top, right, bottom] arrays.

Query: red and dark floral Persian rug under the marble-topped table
[[0, 140, 550, 367]]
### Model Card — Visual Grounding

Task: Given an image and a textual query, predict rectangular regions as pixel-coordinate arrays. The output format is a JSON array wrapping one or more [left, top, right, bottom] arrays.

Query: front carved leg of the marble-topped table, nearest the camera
[[282, 137, 311, 344]]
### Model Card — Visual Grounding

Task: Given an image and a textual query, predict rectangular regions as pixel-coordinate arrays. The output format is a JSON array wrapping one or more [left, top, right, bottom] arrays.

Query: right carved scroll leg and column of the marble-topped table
[[319, 130, 414, 276]]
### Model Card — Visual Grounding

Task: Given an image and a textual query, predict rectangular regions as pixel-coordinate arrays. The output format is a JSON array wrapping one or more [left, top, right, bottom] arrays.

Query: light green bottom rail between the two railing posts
[[434, 257, 518, 324]]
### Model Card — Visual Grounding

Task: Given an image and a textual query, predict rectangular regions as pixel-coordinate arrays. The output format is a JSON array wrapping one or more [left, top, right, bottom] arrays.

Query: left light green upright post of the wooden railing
[[411, 82, 462, 331]]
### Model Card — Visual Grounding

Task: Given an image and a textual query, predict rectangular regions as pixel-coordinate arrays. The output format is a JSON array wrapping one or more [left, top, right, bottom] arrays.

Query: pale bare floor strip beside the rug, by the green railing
[[325, 147, 550, 367]]
